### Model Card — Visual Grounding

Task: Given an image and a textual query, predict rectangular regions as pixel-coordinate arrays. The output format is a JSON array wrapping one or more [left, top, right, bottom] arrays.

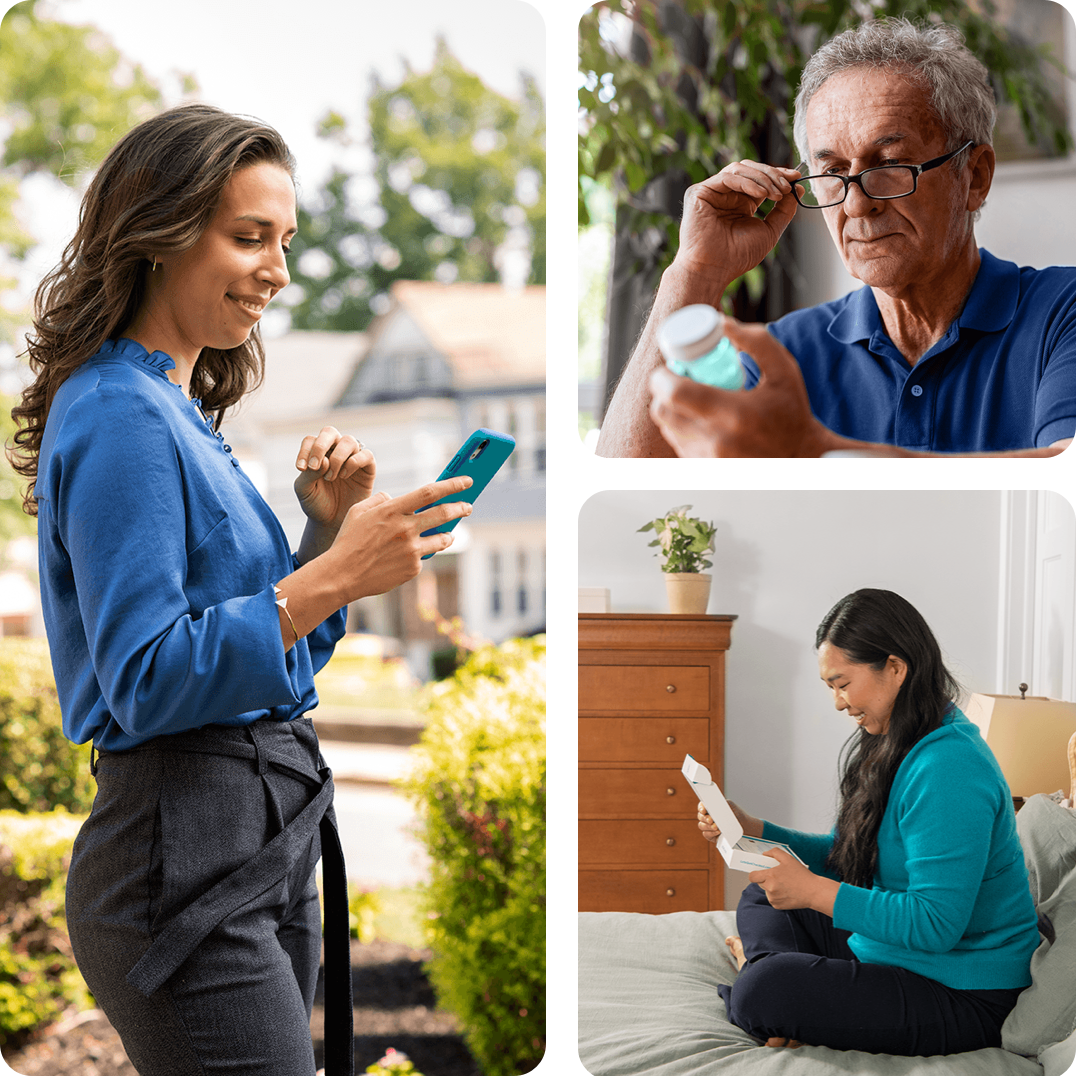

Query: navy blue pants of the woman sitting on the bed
[[718, 884, 1020, 1057]]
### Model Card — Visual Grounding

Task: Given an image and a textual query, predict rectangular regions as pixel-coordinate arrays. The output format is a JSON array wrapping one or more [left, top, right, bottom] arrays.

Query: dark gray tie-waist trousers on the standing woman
[[67, 718, 354, 1076]]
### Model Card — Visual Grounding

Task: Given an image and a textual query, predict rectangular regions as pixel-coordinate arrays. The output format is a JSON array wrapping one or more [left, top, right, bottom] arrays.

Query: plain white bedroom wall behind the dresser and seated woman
[[579, 490, 1002, 907]]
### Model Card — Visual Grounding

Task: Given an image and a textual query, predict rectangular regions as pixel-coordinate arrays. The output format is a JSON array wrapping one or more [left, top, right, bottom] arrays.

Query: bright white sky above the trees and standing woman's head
[[5, 0, 546, 365]]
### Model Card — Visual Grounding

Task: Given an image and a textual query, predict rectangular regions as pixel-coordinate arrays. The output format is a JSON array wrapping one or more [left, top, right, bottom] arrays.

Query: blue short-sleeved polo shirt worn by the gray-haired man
[[740, 247, 1076, 452]]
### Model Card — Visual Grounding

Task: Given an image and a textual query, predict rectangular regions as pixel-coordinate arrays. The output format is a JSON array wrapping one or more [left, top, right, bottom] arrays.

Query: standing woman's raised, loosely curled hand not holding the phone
[[295, 426, 378, 529]]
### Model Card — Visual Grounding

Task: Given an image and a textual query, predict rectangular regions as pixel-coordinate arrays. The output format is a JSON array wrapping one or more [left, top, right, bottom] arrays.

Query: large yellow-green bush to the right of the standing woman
[[402, 635, 546, 1076]]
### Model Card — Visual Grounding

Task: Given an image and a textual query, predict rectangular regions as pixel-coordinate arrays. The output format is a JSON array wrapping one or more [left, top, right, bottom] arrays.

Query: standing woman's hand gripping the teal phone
[[329, 475, 473, 601]]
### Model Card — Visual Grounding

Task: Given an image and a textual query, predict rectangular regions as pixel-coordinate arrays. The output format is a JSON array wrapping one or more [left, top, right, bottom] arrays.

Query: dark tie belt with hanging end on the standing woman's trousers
[[96, 726, 355, 1076]]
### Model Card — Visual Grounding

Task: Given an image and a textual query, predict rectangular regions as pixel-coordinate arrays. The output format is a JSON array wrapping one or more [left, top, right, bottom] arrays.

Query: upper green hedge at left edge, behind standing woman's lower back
[[0, 638, 97, 813]]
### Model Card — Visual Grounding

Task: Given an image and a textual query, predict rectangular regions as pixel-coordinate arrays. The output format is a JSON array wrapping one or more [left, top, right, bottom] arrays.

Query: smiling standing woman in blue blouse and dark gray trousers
[[13, 104, 470, 1076]]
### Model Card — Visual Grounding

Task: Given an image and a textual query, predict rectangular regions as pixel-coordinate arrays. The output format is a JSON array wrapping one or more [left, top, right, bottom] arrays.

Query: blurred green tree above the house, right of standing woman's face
[[289, 38, 546, 331]]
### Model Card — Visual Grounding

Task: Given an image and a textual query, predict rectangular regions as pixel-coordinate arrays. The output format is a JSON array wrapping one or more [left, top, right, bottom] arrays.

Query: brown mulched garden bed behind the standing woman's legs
[[4, 940, 481, 1076]]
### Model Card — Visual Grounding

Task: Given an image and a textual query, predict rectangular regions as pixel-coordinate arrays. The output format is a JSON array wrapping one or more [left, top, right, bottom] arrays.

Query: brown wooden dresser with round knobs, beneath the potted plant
[[579, 613, 736, 914]]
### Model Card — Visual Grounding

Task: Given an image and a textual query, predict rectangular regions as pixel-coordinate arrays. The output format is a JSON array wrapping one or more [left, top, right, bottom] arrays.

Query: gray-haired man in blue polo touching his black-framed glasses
[[597, 18, 1076, 457]]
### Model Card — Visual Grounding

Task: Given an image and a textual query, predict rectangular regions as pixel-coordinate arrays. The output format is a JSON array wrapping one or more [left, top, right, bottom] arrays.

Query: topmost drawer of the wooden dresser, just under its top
[[579, 665, 710, 713]]
